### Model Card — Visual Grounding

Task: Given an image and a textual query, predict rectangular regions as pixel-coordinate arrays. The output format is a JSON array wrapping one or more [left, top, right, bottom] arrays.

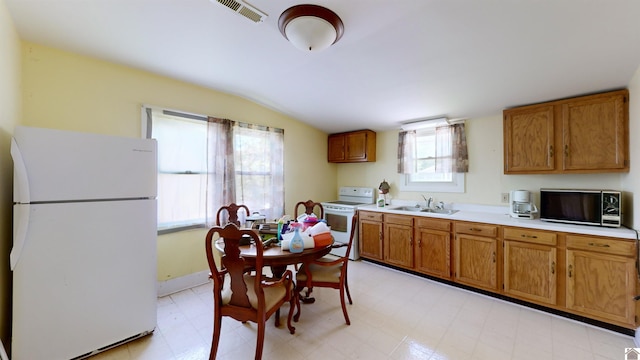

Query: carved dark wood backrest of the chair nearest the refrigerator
[[205, 223, 265, 310]]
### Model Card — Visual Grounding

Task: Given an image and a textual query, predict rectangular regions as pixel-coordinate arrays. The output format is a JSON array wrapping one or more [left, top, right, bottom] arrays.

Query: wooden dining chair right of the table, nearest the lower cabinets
[[293, 213, 358, 325]]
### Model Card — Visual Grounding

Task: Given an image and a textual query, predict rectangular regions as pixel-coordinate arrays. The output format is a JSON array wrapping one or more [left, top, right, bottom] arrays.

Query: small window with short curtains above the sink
[[399, 122, 466, 192]]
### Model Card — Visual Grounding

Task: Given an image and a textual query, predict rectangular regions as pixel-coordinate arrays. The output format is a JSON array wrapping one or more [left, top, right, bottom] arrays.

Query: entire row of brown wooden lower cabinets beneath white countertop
[[359, 211, 640, 329]]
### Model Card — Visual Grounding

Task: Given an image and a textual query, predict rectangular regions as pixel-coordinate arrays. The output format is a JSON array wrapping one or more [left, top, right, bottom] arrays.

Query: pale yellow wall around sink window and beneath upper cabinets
[[338, 100, 640, 214]]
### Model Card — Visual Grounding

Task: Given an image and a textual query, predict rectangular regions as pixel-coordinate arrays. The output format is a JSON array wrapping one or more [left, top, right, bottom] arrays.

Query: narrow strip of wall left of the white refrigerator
[[0, 0, 21, 347]]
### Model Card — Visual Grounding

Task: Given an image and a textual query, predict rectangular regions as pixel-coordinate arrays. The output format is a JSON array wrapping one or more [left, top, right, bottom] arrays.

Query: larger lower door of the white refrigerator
[[12, 199, 157, 360]]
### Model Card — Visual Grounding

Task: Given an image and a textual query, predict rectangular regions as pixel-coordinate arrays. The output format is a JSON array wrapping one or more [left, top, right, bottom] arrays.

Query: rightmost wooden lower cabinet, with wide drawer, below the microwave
[[566, 235, 637, 327]]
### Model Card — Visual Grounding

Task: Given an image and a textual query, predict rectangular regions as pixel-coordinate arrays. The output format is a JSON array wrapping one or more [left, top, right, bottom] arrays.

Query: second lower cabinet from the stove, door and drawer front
[[383, 214, 413, 268]]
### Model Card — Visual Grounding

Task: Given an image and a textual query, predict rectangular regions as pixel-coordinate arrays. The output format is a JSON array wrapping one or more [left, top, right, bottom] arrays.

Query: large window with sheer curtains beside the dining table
[[143, 108, 284, 232]]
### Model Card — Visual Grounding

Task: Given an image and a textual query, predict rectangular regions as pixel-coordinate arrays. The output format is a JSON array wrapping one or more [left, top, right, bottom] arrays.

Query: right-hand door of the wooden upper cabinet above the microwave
[[562, 92, 629, 170]]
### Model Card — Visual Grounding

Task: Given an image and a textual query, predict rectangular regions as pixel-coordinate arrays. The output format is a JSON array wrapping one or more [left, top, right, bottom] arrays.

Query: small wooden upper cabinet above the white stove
[[328, 130, 376, 163]]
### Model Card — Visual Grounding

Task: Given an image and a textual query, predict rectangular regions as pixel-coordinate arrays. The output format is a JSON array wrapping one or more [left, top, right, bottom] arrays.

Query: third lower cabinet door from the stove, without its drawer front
[[415, 228, 451, 279]]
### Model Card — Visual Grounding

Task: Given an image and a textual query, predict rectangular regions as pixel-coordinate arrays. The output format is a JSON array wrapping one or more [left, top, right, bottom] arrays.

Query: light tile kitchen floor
[[91, 261, 635, 360]]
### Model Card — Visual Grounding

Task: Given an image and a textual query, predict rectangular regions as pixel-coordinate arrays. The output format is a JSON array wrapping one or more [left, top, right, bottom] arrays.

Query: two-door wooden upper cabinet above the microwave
[[504, 90, 629, 174]]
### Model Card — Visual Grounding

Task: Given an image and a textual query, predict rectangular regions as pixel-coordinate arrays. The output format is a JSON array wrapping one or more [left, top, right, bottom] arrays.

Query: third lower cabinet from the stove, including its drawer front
[[414, 218, 451, 280]]
